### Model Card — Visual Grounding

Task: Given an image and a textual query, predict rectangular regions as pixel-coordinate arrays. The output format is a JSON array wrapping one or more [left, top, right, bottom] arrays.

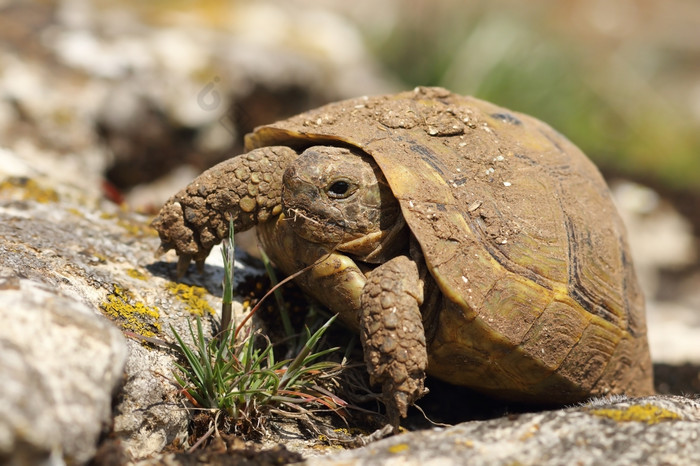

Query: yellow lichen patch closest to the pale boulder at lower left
[[100, 285, 161, 337]]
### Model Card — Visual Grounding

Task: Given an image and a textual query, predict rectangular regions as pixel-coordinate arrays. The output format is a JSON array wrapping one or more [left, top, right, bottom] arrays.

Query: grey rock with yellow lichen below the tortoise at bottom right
[[305, 396, 700, 466]]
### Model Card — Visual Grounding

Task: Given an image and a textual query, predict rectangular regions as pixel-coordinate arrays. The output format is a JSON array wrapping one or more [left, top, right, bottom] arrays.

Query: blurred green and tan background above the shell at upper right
[[336, 0, 700, 191]]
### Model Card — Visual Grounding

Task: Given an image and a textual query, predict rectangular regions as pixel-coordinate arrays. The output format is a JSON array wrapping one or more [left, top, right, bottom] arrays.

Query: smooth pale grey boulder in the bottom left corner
[[0, 278, 126, 464]]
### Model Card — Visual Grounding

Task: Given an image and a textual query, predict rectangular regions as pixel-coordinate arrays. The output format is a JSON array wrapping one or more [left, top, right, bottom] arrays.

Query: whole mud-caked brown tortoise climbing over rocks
[[153, 87, 653, 428]]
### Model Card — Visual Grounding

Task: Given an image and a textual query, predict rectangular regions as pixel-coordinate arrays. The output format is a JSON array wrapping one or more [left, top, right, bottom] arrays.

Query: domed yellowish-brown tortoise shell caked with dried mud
[[246, 88, 652, 402]]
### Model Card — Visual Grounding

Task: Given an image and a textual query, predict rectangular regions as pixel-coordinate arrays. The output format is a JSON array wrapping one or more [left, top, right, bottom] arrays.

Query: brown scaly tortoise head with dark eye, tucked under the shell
[[282, 146, 405, 263]]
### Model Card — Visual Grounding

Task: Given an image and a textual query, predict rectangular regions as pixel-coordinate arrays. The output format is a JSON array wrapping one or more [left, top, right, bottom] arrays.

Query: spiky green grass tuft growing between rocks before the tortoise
[[171, 220, 346, 438]]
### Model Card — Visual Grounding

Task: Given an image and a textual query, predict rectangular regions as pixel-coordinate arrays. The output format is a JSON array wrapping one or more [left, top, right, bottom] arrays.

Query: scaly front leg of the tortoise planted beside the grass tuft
[[360, 256, 428, 432]]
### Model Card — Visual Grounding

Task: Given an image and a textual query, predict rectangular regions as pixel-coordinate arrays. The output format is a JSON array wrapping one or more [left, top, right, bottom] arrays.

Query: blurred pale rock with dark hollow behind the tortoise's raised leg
[[0, 0, 392, 208]]
